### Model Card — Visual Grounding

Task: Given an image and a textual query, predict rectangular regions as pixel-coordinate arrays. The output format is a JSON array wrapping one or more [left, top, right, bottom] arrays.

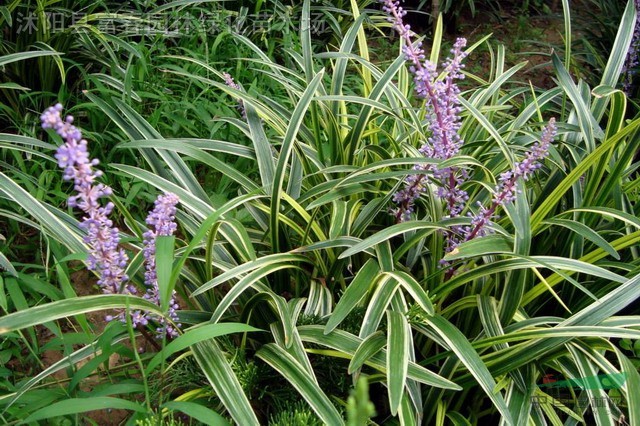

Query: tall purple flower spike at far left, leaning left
[[40, 104, 136, 294]]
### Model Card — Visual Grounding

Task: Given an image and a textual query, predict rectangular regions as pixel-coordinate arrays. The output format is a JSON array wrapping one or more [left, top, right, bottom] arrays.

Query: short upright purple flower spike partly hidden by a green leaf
[[143, 193, 181, 338]]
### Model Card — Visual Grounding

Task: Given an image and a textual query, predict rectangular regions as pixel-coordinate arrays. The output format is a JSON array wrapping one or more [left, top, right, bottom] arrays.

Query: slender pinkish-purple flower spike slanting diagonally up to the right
[[463, 118, 556, 241]]
